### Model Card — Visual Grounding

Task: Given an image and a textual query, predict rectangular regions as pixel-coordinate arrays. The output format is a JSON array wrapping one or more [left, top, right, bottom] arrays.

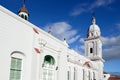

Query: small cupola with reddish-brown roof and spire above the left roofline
[[18, 0, 29, 20]]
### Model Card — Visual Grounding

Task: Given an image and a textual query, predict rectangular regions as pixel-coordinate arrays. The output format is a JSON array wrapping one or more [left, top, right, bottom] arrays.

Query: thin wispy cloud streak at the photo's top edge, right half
[[70, 0, 114, 16]]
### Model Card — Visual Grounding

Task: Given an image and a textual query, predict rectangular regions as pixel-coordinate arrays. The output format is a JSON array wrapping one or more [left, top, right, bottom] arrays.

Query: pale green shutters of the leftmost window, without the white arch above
[[10, 57, 22, 80]]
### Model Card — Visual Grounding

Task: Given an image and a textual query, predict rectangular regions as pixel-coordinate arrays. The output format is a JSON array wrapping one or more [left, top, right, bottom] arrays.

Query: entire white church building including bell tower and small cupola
[[0, 6, 107, 80]]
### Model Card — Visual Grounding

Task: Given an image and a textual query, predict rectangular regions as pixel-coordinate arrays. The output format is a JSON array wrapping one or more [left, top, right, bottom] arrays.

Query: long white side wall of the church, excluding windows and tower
[[0, 6, 104, 80]]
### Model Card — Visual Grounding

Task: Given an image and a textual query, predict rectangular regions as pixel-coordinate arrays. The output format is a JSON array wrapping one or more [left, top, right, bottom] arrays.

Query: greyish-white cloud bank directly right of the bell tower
[[102, 35, 120, 60]]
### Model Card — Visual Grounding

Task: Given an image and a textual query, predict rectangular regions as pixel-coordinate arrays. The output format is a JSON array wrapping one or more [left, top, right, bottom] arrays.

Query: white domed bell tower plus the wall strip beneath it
[[85, 16, 104, 80]]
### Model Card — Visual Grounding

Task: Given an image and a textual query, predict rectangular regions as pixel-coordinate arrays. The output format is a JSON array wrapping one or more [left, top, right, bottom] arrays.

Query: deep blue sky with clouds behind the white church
[[0, 0, 120, 72]]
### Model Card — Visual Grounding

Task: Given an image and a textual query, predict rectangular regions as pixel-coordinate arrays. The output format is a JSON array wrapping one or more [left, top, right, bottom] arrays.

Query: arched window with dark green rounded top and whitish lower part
[[43, 55, 55, 80]]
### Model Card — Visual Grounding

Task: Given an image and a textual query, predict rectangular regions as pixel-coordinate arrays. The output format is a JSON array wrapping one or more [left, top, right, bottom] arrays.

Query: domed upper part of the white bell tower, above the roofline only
[[85, 16, 102, 60]]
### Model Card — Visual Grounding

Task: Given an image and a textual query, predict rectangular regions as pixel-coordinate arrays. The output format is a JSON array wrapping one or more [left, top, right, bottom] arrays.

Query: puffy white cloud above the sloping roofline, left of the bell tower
[[45, 22, 80, 44]]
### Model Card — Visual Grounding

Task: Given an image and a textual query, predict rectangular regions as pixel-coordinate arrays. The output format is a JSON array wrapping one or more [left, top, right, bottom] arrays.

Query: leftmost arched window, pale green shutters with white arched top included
[[10, 52, 24, 80]]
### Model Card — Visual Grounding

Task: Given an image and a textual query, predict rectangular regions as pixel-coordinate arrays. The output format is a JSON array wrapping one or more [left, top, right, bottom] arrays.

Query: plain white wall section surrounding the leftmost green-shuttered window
[[0, 7, 33, 80]]
